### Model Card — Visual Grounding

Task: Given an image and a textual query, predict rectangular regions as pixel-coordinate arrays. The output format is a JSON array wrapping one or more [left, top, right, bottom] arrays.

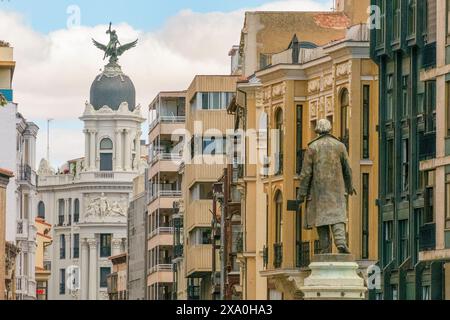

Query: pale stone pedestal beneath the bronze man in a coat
[[300, 254, 367, 300]]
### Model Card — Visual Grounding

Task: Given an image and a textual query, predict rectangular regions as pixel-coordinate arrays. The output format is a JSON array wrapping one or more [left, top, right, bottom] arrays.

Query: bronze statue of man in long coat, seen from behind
[[298, 119, 356, 253]]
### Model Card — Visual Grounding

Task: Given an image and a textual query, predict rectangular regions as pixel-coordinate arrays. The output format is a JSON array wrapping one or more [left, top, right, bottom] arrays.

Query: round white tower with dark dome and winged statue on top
[[80, 28, 145, 177]]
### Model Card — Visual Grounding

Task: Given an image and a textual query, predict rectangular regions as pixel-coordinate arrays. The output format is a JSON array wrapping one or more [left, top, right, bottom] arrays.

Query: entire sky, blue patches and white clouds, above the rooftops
[[0, 0, 333, 166]]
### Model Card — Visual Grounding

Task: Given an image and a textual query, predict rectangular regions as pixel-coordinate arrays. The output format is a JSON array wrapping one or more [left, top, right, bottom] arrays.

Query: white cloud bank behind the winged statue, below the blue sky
[[0, 0, 330, 165]]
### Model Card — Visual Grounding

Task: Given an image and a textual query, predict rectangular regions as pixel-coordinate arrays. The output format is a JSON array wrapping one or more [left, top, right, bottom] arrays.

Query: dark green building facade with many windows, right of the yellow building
[[371, 0, 443, 300]]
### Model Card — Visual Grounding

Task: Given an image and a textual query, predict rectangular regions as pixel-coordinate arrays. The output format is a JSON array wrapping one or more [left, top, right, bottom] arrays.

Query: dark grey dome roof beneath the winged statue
[[90, 64, 136, 111]]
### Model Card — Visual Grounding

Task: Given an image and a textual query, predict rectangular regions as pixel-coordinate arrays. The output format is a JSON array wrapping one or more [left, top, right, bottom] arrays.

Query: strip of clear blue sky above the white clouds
[[0, 0, 329, 33]]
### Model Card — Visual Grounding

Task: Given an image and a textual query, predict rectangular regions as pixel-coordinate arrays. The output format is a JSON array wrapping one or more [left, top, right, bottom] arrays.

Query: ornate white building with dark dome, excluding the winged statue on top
[[38, 59, 147, 300]]
